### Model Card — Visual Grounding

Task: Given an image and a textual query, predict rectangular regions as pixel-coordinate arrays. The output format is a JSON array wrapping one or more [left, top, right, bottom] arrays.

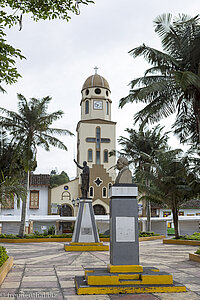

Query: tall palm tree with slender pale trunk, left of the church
[[0, 94, 72, 236]]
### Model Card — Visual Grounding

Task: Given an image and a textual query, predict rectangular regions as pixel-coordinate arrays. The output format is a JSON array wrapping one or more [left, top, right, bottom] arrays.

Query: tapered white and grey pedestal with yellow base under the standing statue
[[64, 199, 109, 251]]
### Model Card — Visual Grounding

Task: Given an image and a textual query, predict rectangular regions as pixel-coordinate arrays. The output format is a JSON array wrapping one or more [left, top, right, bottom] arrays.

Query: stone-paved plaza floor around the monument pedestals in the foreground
[[0, 240, 200, 300]]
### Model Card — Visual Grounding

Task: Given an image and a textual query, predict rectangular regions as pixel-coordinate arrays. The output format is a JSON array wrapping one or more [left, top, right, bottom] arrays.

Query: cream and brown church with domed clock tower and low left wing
[[51, 68, 116, 232]]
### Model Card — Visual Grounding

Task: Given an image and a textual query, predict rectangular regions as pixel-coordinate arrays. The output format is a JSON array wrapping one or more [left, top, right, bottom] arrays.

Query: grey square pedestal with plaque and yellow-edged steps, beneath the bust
[[75, 184, 186, 295]]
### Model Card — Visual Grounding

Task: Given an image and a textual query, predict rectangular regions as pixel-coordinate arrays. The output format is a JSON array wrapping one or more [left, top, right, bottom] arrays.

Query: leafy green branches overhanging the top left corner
[[0, 0, 93, 92]]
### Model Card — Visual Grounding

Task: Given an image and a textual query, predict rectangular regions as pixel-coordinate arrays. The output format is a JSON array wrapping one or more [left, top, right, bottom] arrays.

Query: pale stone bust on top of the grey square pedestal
[[115, 157, 132, 183]]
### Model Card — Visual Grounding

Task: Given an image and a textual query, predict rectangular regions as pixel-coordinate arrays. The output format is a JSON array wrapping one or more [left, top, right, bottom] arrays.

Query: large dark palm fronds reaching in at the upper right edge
[[119, 14, 200, 144]]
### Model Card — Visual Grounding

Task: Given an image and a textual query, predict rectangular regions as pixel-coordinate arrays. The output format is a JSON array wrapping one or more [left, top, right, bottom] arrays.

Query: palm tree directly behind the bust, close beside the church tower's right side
[[118, 126, 168, 232]]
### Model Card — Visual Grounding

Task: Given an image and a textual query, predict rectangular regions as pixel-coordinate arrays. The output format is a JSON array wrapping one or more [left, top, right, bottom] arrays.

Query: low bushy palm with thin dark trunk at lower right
[[137, 149, 200, 238]]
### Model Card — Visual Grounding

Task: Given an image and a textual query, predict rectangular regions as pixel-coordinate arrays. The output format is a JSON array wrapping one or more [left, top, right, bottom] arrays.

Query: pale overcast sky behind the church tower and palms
[[0, 0, 199, 178]]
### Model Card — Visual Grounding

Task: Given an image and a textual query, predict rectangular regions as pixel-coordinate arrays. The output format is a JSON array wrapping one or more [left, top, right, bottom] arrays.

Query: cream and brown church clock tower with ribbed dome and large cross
[[77, 68, 116, 214]]
